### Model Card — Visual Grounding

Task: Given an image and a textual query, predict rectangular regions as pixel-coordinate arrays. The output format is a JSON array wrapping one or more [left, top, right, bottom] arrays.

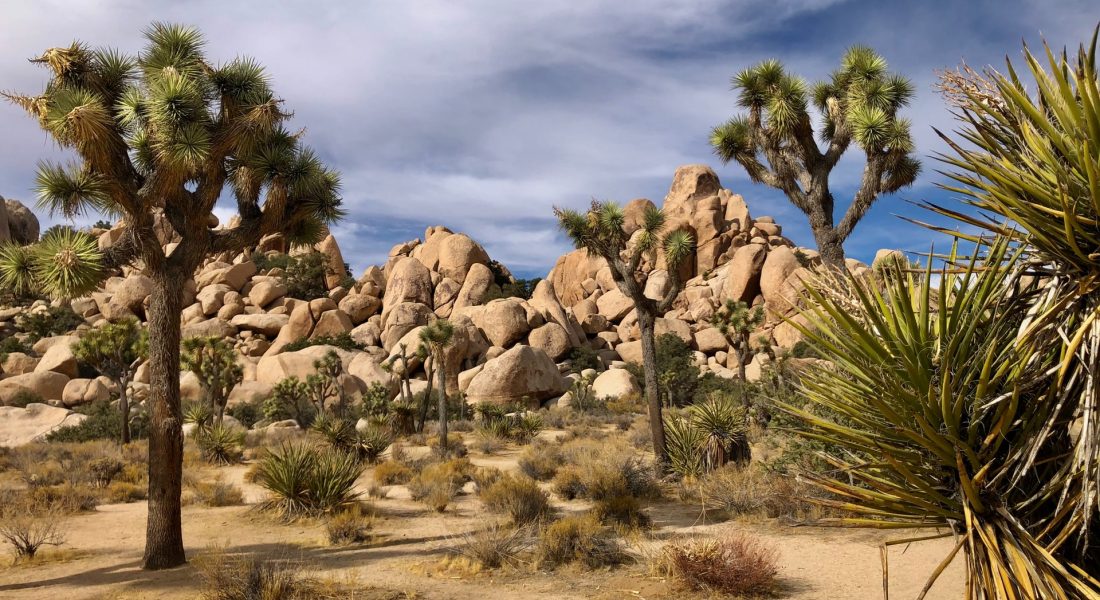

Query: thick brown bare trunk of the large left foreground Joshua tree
[[142, 266, 187, 569]]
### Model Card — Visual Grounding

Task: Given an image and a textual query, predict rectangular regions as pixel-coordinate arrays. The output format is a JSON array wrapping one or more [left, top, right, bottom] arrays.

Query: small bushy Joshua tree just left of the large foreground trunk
[[73, 319, 149, 444]]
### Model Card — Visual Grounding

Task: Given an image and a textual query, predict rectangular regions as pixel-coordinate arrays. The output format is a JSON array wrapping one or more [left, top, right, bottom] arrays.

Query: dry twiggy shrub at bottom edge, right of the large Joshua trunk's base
[[195, 550, 318, 600]]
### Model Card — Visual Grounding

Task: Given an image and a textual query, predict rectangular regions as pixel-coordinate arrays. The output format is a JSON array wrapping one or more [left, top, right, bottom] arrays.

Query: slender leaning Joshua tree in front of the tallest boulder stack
[[554, 200, 695, 462]]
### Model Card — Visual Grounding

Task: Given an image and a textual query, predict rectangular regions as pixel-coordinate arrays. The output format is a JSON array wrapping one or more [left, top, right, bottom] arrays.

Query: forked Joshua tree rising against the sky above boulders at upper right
[[711, 46, 921, 269]]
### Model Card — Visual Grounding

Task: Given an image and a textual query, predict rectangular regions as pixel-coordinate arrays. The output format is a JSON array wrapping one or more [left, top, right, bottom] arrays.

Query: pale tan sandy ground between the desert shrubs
[[0, 442, 964, 600]]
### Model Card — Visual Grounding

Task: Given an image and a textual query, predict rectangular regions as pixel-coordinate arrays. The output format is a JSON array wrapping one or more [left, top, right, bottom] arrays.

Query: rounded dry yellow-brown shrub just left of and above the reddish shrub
[[537, 514, 628, 568]]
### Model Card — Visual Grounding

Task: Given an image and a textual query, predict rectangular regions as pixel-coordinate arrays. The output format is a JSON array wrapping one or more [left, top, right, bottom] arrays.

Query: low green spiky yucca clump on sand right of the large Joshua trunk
[[256, 444, 362, 519]]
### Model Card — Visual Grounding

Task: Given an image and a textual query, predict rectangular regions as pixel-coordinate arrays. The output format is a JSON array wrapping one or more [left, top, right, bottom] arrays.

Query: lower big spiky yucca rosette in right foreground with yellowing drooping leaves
[[787, 240, 1100, 599]]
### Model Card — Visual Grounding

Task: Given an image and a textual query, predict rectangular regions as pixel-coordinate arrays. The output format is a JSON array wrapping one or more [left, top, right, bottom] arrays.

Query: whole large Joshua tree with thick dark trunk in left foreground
[[6, 23, 342, 569]]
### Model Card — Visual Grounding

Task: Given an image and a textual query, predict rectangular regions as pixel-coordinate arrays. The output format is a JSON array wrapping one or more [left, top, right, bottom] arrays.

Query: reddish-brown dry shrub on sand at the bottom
[[662, 534, 779, 596]]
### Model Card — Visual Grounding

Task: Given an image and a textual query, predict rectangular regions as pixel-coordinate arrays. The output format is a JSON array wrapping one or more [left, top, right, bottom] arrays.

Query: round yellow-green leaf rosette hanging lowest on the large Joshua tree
[[31, 228, 105, 298]]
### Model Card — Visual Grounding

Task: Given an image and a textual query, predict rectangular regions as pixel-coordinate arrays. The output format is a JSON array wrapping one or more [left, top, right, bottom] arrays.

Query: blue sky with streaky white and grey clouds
[[0, 0, 1100, 276]]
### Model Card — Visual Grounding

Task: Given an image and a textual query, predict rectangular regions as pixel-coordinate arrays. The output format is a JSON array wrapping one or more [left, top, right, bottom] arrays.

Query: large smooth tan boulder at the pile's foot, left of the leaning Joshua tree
[[466, 345, 569, 407]]
